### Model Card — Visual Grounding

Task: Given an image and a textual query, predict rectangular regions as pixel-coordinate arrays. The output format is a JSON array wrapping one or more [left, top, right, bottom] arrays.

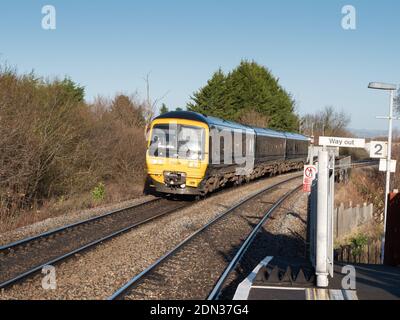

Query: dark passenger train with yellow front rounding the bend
[[145, 111, 310, 196]]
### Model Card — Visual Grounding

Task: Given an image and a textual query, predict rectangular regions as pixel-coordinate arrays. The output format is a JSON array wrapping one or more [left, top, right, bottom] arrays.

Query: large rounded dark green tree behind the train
[[188, 61, 298, 131]]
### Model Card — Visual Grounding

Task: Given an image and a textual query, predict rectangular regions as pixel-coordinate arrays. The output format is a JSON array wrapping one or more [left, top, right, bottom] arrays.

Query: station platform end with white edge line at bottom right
[[233, 257, 400, 300]]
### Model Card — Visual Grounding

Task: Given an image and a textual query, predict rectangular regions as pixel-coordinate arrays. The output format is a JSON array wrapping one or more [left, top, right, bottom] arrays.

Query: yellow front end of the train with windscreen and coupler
[[146, 119, 209, 195]]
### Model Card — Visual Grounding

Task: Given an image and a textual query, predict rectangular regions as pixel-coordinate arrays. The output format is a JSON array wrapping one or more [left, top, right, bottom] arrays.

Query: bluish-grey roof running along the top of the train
[[155, 111, 309, 141]]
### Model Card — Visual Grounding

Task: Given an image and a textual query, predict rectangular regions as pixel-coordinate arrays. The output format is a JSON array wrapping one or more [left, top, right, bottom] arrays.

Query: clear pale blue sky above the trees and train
[[0, 0, 400, 129]]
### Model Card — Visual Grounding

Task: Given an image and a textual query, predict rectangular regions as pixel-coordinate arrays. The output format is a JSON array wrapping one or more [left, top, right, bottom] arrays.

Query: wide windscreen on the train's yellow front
[[149, 124, 205, 160]]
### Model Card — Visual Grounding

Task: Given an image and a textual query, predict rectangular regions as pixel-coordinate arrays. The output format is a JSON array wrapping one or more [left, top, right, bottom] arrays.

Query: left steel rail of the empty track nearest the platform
[[107, 174, 302, 300]]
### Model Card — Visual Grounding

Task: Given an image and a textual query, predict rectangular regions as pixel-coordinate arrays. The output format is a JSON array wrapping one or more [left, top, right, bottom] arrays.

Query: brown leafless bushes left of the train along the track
[[0, 67, 146, 229]]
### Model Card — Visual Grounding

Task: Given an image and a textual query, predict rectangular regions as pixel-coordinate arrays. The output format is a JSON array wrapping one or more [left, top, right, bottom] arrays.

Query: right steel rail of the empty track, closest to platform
[[207, 186, 301, 300]]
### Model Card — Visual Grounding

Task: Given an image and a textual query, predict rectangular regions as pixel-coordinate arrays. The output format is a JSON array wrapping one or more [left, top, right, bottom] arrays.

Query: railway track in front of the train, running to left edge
[[0, 198, 191, 289]]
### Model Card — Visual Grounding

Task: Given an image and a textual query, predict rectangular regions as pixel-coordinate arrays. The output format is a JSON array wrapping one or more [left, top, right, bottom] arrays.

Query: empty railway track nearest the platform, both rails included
[[109, 176, 299, 300]]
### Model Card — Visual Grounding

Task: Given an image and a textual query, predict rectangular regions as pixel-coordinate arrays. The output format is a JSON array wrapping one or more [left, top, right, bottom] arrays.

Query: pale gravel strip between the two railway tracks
[[0, 173, 304, 299]]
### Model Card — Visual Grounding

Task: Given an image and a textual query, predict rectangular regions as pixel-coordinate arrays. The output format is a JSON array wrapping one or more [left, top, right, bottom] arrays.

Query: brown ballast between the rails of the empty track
[[120, 179, 300, 300]]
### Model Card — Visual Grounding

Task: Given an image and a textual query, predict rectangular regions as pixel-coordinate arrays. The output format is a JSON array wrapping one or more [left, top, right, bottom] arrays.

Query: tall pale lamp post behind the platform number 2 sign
[[368, 82, 397, 264]]
